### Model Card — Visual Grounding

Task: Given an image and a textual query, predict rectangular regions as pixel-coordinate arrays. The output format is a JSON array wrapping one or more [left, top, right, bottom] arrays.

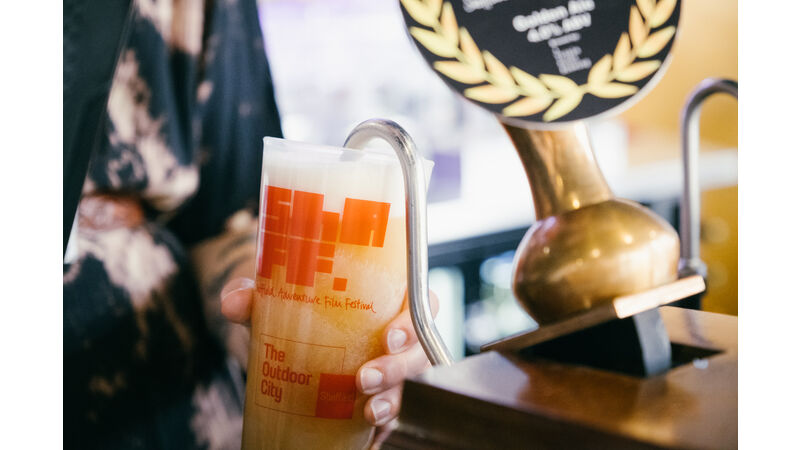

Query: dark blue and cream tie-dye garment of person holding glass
[[64, 0, 281, 449]]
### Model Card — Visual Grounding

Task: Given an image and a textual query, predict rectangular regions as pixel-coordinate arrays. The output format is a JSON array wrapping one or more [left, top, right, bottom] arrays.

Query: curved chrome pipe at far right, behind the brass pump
[[679, 78, 739, 278]]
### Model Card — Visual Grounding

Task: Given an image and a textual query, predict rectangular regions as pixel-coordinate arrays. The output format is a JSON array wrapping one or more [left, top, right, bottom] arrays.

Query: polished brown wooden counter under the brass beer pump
[[374, 307, 738, 449]]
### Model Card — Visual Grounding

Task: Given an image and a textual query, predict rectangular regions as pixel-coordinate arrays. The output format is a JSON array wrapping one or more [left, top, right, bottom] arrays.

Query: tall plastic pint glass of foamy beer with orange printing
[[242, 138, 432, 449]]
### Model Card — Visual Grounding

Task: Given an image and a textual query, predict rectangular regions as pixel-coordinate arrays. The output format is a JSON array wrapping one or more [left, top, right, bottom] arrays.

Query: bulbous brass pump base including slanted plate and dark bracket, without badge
[[468, 119, 688, 376]]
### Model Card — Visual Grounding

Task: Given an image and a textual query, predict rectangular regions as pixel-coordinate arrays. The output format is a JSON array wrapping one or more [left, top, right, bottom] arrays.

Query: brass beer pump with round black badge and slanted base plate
[[400, 0, 704, 376]]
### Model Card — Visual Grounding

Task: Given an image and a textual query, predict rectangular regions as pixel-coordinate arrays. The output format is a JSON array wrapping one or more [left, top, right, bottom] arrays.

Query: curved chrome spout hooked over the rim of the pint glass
[[344, 119, 453, 366]]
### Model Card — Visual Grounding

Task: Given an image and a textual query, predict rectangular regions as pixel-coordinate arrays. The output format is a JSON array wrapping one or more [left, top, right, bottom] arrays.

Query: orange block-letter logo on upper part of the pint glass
[[258, 186, 391, 291]]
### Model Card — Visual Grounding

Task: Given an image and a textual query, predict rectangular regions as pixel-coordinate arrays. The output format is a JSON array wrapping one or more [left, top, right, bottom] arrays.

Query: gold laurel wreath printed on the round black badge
[[400, 0, 677, 122]]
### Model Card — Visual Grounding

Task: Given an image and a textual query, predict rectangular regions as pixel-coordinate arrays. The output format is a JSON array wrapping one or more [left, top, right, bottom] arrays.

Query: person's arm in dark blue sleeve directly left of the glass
[[164, 0, 282, 370]]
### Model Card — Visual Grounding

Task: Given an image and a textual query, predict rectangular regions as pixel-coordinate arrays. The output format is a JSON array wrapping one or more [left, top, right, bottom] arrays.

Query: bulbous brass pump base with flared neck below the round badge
[[503, 124, 679, 324]]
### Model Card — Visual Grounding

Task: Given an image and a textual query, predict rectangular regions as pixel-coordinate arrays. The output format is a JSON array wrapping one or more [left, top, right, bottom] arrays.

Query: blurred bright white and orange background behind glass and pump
[[259, 0, 738, 357]]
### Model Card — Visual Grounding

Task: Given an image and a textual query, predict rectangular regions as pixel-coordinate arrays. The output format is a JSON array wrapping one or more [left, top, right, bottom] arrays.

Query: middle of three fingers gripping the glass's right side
[[356, 345, 430, 394]]
